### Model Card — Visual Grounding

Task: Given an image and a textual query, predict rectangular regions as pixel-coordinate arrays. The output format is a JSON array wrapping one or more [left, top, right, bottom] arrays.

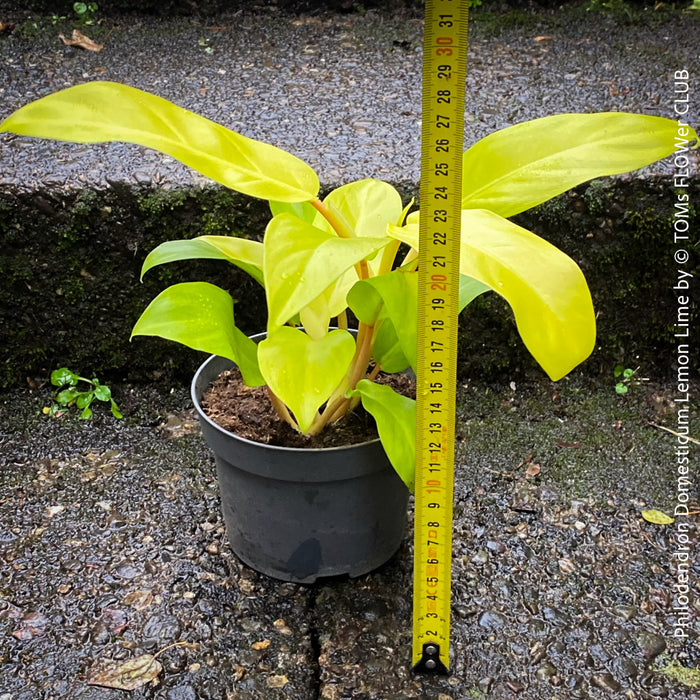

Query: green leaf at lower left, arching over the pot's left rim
[[131, 282, 265, 386]]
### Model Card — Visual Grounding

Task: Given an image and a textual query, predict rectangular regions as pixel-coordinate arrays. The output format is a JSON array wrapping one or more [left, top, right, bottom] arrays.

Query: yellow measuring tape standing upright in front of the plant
[[413, 0, 469, 673]]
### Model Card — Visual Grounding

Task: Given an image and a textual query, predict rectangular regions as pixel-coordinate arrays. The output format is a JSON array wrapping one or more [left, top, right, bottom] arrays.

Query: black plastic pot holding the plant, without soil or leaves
[[192, 350, 408, 583]]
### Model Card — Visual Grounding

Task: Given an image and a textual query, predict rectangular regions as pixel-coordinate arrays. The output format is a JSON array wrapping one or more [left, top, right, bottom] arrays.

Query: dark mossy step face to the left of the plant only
[[0, 187, 264, 386]]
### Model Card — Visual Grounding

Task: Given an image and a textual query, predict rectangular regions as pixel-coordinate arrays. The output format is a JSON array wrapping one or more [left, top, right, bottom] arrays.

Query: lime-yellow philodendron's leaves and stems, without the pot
[[0, 82, 697, 487]]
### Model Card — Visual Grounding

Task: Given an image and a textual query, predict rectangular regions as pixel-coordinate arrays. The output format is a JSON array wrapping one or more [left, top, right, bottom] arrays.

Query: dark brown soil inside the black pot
[[202, 368, 415, 448]]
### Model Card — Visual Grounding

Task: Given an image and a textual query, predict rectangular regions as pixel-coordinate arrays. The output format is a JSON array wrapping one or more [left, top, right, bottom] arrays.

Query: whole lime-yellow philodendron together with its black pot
[[0, 82, 697, 581]]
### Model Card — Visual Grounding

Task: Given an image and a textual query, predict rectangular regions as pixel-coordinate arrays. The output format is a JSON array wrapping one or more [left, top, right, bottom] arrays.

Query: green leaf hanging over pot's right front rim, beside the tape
[[352, 379, 416, 491]]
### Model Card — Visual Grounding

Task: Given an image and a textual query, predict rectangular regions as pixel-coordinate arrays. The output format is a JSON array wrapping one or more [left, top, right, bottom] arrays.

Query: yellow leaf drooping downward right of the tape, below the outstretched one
[[390, 209, 595, 381]]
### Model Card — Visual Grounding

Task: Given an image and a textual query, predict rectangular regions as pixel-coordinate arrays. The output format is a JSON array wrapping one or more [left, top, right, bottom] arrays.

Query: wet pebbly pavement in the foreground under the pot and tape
[[0, 377, 700, 700]]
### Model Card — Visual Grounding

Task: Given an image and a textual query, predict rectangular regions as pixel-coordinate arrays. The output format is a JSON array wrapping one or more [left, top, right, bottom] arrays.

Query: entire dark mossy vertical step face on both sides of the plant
[[0, 181, 700, 386]]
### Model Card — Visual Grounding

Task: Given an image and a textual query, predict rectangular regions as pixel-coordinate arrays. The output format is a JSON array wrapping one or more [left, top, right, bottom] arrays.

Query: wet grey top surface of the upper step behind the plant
[[0, 7, 700, 190]]
